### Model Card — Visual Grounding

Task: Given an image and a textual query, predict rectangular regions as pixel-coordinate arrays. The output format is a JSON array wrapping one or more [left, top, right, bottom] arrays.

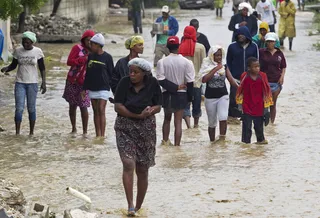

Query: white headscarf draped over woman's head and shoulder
[[199, 45, 225, 79]]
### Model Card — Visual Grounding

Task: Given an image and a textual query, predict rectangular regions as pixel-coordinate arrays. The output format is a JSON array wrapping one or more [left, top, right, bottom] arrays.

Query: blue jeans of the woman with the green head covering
[[14, 82, 38, 122]]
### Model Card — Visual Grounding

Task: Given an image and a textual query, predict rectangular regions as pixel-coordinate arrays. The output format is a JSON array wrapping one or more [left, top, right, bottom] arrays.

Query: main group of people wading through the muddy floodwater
[[1, 3, 292, 216]]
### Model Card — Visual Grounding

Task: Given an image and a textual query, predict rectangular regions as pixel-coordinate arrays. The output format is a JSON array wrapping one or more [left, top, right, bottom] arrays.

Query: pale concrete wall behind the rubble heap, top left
[[40, 0, 109, 23]]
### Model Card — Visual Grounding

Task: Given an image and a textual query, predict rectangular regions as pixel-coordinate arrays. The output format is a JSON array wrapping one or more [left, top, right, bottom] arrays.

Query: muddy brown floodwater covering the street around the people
[[0, 4, 320, 218]]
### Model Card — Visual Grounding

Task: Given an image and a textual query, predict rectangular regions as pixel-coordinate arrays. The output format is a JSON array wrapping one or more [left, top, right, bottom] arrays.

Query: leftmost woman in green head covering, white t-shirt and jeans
[[1, 31, 47, 135]]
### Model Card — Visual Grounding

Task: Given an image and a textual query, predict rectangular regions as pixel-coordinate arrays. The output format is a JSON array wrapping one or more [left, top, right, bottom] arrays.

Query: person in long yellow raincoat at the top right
[[279, 0, 297, 51]]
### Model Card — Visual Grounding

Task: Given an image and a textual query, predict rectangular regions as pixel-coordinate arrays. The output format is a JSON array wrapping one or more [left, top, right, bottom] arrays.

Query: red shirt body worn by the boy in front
[[242, 76, 264, 117]]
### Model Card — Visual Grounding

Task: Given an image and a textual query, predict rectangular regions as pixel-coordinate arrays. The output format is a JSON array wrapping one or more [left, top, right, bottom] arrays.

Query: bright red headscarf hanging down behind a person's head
[[179, 26, 197, 57]]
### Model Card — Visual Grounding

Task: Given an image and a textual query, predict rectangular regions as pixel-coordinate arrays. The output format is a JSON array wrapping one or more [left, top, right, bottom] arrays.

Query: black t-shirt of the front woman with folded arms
[[114, 76, 162, 114]]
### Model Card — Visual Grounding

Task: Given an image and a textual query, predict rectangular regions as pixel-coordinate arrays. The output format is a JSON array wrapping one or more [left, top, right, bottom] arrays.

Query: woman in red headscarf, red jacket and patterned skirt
[[63, 30, 94, 135]]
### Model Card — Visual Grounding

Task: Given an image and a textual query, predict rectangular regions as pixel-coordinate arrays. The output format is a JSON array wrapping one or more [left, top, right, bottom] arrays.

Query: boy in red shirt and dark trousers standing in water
[[236, 57, 273, 144]]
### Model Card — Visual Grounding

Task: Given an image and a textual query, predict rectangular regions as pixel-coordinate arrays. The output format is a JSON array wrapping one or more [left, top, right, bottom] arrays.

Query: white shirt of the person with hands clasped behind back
[[156, 54, 195, 92]]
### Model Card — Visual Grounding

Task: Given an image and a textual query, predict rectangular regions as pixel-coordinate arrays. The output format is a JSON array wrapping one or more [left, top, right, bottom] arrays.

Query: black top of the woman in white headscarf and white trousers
[[204, 67, 228, 98]]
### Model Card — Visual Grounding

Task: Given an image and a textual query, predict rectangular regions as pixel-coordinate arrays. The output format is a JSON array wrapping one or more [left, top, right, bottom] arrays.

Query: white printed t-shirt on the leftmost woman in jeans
[[13, 46, 44, 83]]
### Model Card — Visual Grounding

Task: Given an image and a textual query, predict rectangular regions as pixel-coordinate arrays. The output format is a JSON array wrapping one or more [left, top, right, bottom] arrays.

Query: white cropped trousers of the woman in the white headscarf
[[204, 95, 229, 128]]
